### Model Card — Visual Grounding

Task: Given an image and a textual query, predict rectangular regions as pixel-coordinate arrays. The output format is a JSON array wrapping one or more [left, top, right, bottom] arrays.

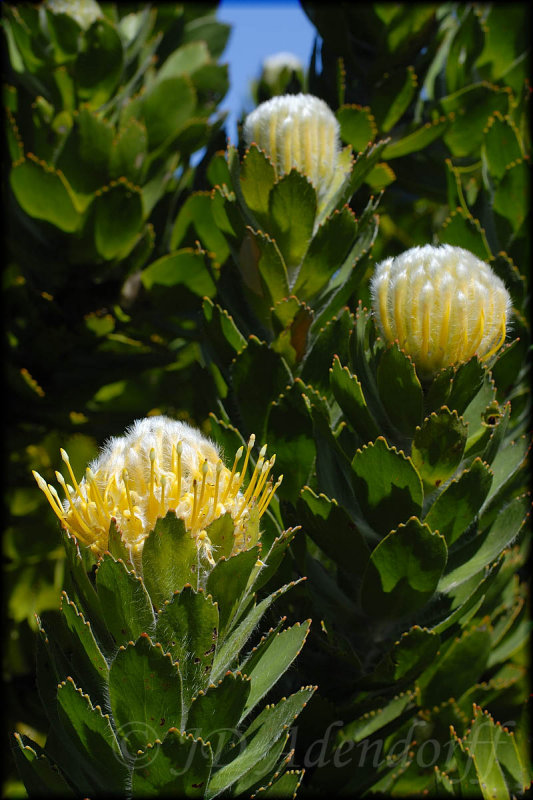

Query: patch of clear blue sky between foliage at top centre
[[217, 0, 315, 144]]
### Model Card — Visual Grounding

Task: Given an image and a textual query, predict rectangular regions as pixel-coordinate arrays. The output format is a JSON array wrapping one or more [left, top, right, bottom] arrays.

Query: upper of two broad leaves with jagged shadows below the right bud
[[352, 436, 423, 535]]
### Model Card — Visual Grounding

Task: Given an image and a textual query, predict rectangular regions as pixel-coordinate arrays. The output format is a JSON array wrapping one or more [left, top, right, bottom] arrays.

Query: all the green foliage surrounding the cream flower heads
[[5, 2, 531, 800]]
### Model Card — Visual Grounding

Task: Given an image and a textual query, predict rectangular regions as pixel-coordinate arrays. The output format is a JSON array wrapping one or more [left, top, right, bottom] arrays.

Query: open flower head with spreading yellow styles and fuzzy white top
[[33, 416, 282, 563]]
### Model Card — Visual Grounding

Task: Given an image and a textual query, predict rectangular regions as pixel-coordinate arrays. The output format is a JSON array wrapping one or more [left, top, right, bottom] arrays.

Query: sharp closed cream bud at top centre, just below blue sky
[[243, 94, 340, 203]]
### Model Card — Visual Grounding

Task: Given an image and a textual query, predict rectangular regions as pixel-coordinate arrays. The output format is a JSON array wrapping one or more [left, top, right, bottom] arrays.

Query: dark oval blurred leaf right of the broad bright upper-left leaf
[[94, 180, 144, 261]]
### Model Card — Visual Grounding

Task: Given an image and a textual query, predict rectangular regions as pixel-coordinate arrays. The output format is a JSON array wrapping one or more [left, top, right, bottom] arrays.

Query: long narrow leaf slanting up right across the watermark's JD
[[207, 687, 314, 798]]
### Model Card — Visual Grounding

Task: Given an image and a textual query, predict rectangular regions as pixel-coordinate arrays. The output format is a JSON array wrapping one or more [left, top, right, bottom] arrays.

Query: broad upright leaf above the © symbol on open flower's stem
[[109, 633, 183, 755]]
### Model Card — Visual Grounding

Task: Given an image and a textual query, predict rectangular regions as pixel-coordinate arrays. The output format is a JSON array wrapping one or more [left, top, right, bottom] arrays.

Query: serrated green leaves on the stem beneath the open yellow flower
[[15, 512, 314, 797]]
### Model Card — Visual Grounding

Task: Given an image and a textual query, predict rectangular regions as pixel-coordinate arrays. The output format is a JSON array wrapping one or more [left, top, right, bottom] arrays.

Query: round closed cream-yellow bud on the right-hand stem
[[370, 244, 511, 379]]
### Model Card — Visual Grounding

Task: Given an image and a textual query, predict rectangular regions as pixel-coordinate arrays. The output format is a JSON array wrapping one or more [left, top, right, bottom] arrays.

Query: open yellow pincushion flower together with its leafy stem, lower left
[[15, 416, 314, 797]]
